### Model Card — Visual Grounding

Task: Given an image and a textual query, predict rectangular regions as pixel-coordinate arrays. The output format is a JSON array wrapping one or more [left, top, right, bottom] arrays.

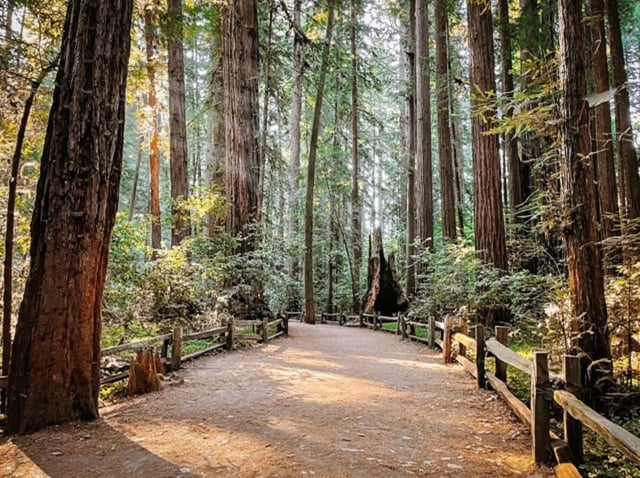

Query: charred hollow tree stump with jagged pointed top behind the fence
[[362, 228, 409, 316]]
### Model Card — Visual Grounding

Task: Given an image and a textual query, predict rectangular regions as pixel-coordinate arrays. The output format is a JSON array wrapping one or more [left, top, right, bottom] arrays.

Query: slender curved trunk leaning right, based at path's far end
[[304, 0, 335, 324]]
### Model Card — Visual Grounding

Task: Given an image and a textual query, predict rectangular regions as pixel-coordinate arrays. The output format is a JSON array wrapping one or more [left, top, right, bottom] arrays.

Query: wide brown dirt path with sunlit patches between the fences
[[0, 323, 553, 478]]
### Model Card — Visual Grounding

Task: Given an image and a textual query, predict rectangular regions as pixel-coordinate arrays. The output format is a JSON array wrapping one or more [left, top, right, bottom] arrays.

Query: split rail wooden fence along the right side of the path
[[304, 313, 640, 478]]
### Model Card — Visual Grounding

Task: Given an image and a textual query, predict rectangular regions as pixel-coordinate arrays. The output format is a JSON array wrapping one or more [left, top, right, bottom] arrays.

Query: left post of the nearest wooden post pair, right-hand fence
[[531, 352, 551, 465]]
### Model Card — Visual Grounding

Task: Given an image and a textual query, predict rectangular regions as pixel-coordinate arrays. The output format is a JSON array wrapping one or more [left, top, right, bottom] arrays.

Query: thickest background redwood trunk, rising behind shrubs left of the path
[[222, 0, 260, 253]]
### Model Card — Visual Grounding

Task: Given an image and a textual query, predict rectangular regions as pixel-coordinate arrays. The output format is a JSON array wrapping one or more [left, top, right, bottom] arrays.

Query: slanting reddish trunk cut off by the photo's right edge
[[607, 0, 640, 219]]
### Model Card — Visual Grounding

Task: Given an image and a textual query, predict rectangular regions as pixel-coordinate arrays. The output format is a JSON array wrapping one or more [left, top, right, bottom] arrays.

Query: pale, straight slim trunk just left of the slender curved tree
[[287, 0, 304, 310]]
